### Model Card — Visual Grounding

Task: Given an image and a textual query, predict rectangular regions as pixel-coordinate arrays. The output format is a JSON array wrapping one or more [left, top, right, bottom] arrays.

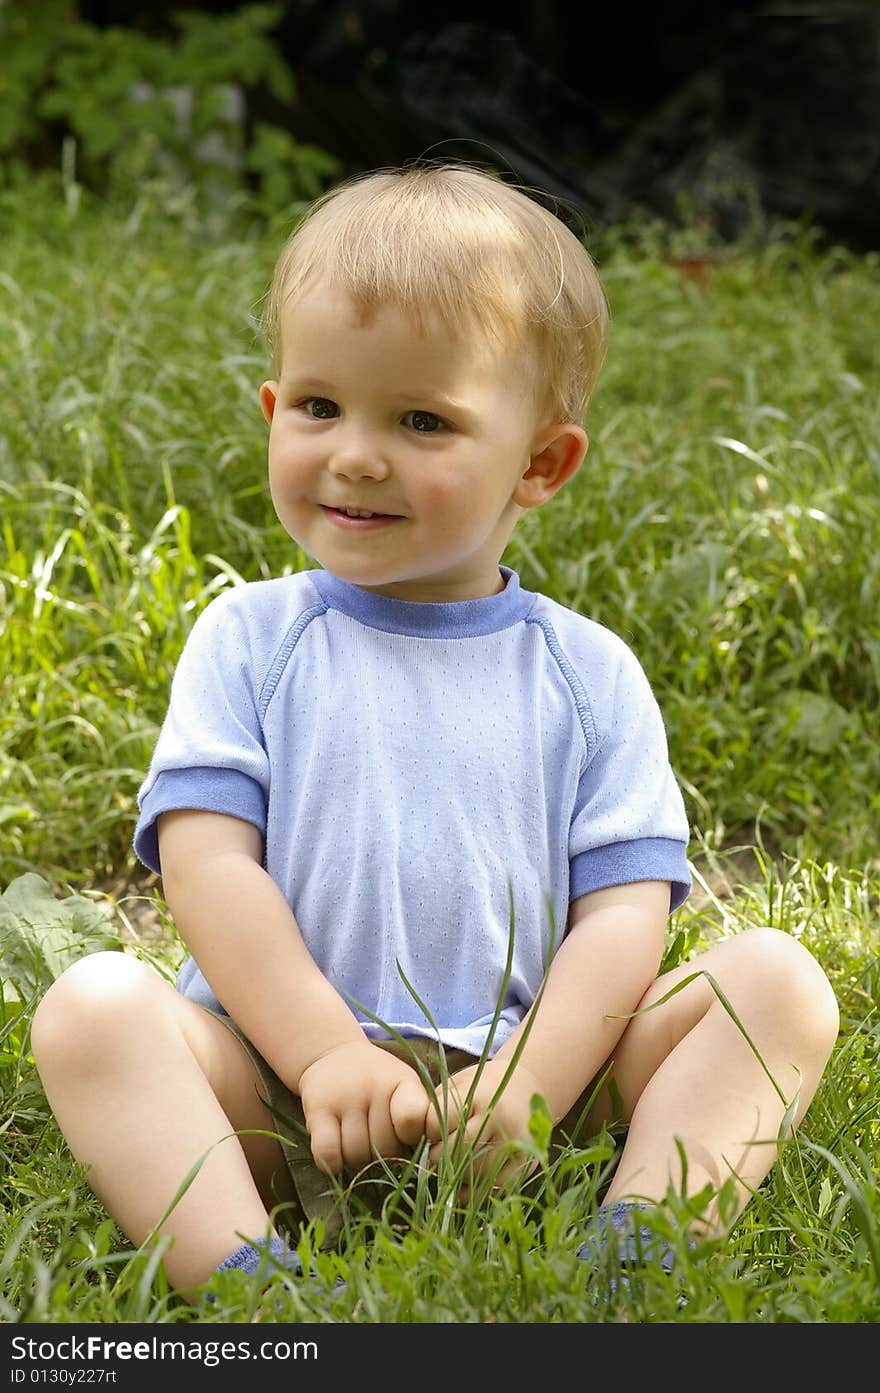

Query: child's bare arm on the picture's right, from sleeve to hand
[[427, 880, 670, 1155]]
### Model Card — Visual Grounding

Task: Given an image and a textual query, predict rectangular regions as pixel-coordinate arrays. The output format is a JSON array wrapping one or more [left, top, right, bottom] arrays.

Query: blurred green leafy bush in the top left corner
[[0, 0, 340, 213]]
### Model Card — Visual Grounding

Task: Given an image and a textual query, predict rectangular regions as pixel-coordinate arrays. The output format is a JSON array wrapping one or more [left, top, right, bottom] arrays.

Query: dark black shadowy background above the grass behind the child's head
[[77, 0, 880, 249]]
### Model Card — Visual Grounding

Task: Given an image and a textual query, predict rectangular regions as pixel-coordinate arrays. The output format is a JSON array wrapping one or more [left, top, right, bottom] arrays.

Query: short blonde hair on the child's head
[[262, 163, 608, 421]]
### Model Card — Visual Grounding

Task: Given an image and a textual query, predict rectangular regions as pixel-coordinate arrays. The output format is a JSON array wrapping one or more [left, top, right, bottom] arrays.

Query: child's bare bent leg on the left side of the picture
[[32, 953, 299, 1290]]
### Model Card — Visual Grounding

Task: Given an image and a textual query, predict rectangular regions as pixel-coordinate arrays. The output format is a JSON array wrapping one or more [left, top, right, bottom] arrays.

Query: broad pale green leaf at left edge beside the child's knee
[[0, 873, 123, 999]]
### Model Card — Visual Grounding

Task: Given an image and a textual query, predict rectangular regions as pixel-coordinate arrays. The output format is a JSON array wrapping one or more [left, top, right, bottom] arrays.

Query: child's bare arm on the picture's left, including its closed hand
[[159, 809, 425, 1172]]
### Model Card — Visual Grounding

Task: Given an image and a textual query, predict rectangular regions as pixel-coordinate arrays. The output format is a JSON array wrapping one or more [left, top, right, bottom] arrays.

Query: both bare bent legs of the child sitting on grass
[[32, 929, 838, 1291]]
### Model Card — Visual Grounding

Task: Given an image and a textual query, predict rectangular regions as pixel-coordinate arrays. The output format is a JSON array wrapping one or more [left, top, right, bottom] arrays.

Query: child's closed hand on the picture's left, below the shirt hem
[[299, 1039, 429, 1174]]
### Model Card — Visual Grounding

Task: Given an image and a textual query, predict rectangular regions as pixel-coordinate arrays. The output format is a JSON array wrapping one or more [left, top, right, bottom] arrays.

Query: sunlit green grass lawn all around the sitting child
[[0, 179, 880, 1323]]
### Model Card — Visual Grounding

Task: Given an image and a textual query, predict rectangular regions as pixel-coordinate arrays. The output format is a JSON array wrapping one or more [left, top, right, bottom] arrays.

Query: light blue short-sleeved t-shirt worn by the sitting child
[[134, 567, 691, 1055]]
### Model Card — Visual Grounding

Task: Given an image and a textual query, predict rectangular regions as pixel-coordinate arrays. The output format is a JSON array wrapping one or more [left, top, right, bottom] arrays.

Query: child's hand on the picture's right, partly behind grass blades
[[425, 1060, 542, 1190]]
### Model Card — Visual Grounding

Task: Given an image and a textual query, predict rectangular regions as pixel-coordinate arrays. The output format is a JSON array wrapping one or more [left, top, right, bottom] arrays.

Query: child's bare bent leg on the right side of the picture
[[593, 929, 838, 1222]]
